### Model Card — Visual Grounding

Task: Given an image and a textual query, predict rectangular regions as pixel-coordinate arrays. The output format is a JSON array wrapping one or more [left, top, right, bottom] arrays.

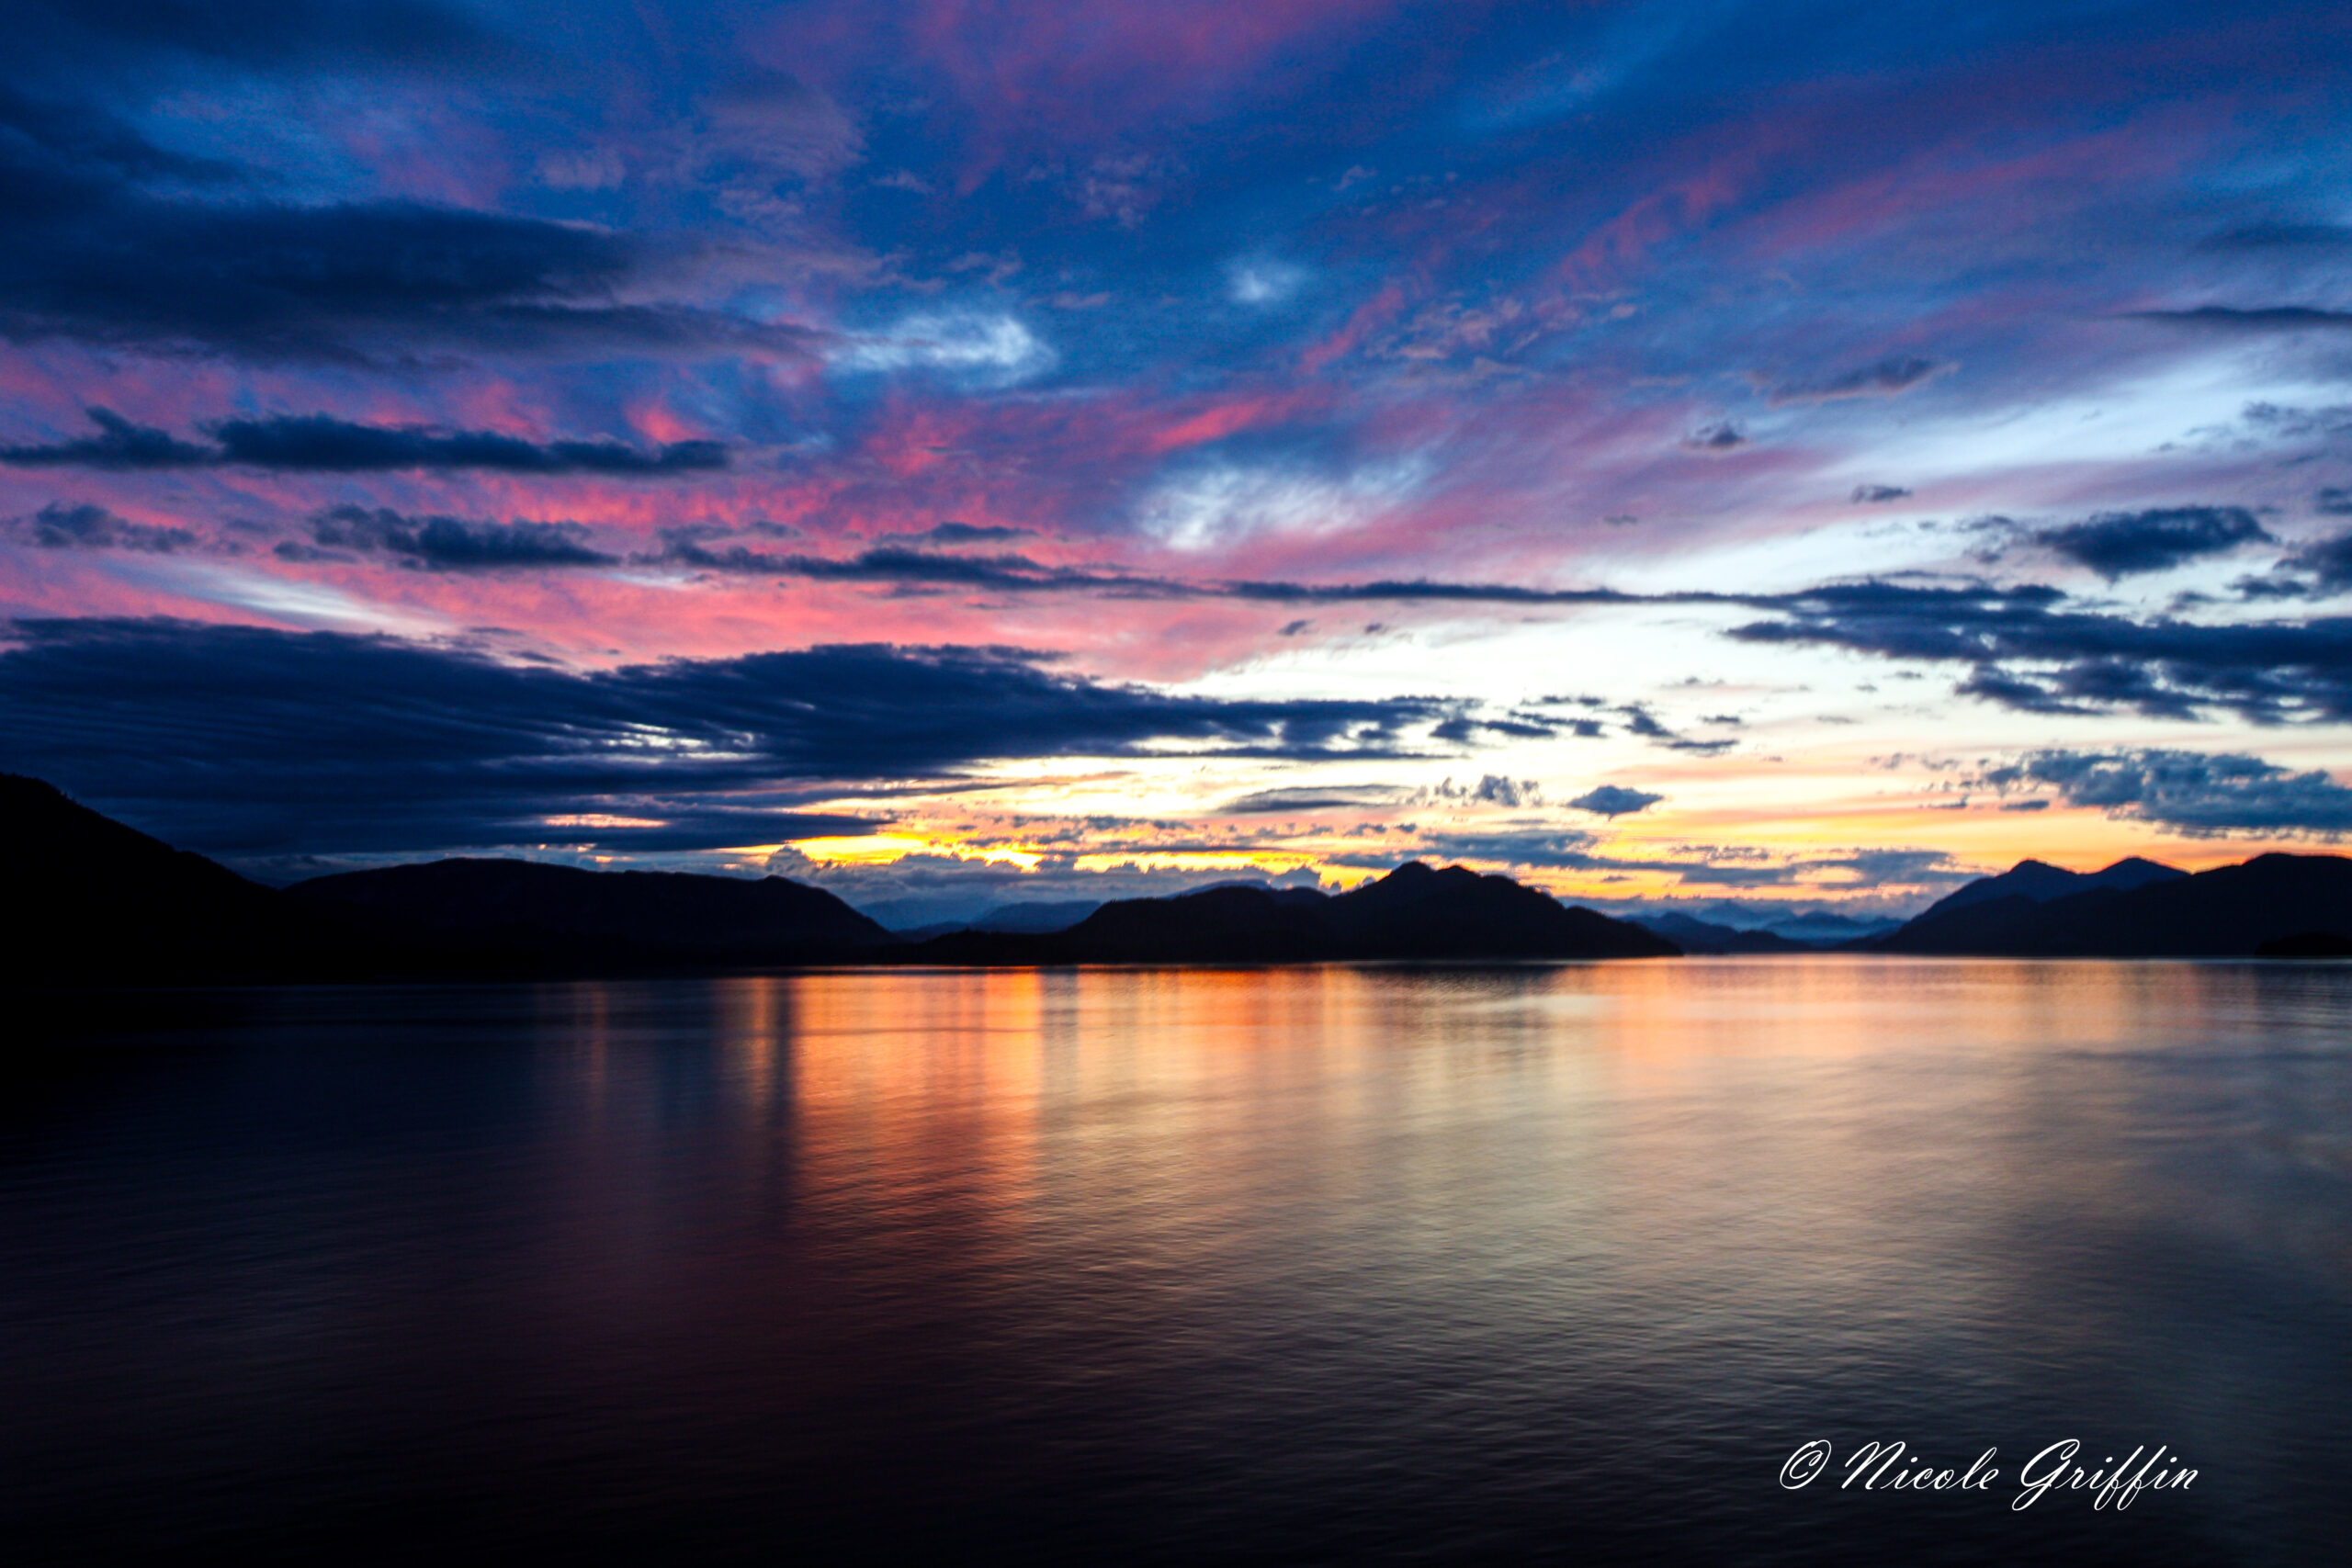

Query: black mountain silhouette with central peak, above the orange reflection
[[889, 861, 1679, 964]]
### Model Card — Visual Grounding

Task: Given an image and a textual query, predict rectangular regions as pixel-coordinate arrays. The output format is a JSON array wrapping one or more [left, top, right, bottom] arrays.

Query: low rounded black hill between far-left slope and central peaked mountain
[[287, 861, 896, 968]]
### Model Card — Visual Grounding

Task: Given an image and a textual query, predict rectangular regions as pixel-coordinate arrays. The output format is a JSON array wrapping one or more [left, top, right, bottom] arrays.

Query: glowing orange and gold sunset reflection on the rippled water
[[691, 957, 2333, 1309]]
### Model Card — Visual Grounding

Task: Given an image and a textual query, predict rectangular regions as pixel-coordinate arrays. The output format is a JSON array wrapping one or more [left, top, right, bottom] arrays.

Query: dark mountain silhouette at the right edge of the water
[[1872, 856, 2352, 959]]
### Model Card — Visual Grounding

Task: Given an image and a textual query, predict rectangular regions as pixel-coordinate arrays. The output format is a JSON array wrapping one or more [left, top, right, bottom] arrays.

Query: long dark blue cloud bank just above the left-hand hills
[[0, 621, 1449, 853]]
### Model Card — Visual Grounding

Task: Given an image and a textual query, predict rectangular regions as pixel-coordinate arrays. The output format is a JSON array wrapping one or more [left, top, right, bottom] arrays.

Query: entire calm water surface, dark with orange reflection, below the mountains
[[0, 959, 2352, 1563]]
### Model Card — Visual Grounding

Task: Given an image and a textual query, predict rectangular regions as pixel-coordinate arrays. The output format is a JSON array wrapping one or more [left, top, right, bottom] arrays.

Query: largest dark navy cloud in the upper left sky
[[0, 92, 809, 360]]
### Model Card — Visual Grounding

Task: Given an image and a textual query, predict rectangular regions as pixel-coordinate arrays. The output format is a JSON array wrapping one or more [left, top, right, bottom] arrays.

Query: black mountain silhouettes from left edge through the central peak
[[0, 776, 1677, 985]]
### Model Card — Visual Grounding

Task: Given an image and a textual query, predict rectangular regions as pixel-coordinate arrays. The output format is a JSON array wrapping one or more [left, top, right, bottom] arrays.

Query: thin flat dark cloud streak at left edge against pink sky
[[0, 409, 727, 478]]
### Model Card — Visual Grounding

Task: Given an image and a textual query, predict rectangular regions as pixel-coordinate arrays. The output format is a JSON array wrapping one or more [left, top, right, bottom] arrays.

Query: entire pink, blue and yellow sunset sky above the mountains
[[0, 0, 2352, 924]]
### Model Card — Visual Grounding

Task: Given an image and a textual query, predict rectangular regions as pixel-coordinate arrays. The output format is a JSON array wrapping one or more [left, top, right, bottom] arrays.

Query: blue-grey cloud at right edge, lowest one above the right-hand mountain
[[1981, 750, 2352, 837]]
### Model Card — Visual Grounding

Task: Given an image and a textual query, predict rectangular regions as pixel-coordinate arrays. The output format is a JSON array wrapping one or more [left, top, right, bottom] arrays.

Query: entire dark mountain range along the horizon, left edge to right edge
[[18, 776, 2352, 987]]
